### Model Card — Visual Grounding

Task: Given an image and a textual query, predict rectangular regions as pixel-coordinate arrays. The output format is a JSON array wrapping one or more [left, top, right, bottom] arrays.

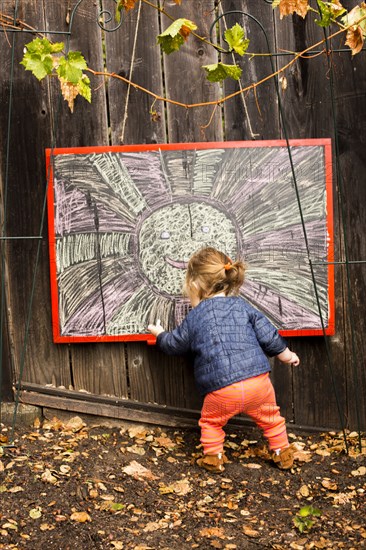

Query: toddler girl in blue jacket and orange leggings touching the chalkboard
[[148, 247, 300, 472]]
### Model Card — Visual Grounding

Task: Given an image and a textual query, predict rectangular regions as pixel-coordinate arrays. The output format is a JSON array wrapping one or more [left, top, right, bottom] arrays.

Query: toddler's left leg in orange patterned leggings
[[198, 384, 242, 455]]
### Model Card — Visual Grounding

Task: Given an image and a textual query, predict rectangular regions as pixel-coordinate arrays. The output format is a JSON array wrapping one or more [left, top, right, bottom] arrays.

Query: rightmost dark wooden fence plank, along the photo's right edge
[[328, 24, 366, 429]]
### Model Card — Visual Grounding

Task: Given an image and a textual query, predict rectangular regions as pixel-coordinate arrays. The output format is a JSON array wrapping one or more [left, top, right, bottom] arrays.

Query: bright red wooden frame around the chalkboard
[[46, 138, 335, 344]]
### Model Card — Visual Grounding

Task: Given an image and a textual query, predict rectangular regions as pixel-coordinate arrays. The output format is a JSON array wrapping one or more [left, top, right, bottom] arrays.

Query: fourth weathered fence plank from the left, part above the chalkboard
[[162, 0, 223, 143]]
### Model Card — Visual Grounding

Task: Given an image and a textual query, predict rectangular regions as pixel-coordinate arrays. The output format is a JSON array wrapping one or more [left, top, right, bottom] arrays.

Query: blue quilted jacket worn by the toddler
[[157, 296, 287, 395]]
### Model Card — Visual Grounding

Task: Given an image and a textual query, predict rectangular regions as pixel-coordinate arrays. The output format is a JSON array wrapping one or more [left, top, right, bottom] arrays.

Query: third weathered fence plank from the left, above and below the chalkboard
[[104, 2, 169, 404]]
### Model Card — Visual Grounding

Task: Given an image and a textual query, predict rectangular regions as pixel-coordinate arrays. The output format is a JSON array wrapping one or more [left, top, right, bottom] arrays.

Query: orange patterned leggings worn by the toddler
[[199, 372, 289, 454]]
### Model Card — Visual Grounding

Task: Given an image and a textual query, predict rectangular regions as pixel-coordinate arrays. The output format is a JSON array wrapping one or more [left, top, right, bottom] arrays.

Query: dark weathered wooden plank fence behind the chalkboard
[[0, 0, 366, 429]]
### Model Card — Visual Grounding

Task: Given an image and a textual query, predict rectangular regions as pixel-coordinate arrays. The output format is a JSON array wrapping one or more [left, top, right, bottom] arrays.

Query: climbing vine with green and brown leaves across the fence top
[[14, 0, 366, 111]]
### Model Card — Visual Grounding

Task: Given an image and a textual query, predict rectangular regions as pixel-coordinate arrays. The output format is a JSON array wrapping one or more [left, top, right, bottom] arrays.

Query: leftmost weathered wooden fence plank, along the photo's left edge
[[0, 0, 70, 386]]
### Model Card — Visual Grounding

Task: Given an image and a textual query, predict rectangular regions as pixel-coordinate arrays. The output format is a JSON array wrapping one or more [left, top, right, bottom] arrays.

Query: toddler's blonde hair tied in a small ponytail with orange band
[[185, 247, 245, 300]]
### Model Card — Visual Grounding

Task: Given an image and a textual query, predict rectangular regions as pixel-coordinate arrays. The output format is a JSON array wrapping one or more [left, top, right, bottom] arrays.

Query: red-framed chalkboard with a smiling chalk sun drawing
[[46, 139, 334, 343]]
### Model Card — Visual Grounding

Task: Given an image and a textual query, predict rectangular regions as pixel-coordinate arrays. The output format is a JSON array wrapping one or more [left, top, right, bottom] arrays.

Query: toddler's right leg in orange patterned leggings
[[244, 374, 289, 450]]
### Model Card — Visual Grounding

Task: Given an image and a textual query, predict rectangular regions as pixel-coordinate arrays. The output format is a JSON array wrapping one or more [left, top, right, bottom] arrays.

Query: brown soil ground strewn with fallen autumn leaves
[[0, 417, 366, 550]]
